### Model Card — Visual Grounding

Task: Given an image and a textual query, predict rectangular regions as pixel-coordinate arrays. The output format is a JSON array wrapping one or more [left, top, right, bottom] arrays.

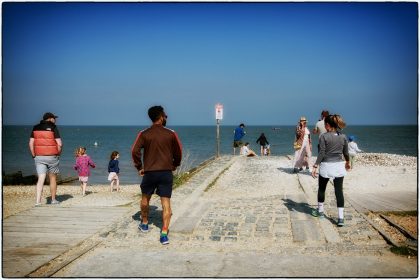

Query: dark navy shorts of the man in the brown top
[[140, 171, 173, 198]]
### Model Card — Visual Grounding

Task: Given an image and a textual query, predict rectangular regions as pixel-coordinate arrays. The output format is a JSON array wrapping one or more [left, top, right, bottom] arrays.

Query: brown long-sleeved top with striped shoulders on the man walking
[[131, 124, 182, 172]]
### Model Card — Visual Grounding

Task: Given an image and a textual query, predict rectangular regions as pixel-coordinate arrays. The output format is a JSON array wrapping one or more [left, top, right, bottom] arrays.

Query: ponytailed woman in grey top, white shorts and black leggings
[[312, 115, 350, 227]]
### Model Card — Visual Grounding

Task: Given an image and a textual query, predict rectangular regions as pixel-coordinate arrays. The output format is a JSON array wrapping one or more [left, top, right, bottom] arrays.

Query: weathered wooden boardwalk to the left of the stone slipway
[[2, 205, 128, 277]]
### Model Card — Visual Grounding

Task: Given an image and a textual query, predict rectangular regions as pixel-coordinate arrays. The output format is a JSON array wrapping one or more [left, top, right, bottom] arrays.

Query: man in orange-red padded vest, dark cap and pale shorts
[[29, 112, 63, 206]]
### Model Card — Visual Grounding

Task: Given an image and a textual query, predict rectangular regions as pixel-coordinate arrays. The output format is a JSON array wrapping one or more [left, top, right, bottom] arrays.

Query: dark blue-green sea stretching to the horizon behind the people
[[2, 125, 418, 185]]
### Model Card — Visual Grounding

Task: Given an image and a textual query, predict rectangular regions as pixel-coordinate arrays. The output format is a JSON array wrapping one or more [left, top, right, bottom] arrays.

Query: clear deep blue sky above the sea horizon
[[2, 2, 418, 125]]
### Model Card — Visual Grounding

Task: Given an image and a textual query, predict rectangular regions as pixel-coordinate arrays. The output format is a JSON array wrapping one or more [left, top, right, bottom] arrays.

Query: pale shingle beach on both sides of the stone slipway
[[3, 153, 417, 218]]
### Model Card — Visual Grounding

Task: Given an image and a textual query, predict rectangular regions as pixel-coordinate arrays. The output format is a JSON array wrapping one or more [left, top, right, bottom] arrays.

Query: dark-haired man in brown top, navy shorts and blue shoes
[[131, 106, 182, 245]]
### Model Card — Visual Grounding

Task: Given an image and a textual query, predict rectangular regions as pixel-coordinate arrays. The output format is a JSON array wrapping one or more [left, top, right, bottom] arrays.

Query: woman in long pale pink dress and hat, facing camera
[[293, 117, 312, 173]]
